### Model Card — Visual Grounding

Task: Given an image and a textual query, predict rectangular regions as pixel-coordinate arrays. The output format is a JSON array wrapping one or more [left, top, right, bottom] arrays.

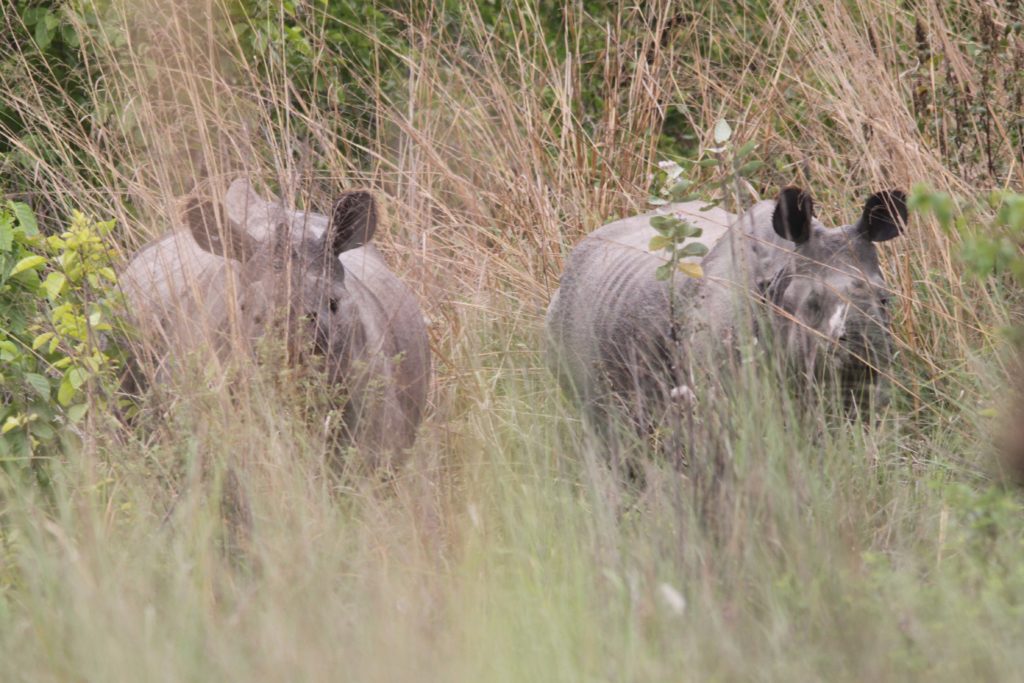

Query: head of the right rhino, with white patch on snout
[[766, 187, 907, 397]]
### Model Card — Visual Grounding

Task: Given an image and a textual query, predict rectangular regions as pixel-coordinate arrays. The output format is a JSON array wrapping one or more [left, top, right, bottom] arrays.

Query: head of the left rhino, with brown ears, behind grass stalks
[[185, 185, 377, 376]]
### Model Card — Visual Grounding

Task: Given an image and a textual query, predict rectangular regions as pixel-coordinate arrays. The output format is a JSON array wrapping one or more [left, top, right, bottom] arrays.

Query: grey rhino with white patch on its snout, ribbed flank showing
[[545, 187, 906, 429]]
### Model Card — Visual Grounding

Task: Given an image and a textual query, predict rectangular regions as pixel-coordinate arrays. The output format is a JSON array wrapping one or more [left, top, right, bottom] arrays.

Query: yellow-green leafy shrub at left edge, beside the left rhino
[[0, 202, 122, 468]]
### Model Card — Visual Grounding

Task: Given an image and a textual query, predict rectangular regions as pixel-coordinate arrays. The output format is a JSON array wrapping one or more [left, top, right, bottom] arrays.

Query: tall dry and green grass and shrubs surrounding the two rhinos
[[0, 0, 1024, 681]]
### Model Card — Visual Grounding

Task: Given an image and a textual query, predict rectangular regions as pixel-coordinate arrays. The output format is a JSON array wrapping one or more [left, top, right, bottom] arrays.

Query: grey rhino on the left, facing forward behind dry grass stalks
[[121, 180, 431, 462]]
